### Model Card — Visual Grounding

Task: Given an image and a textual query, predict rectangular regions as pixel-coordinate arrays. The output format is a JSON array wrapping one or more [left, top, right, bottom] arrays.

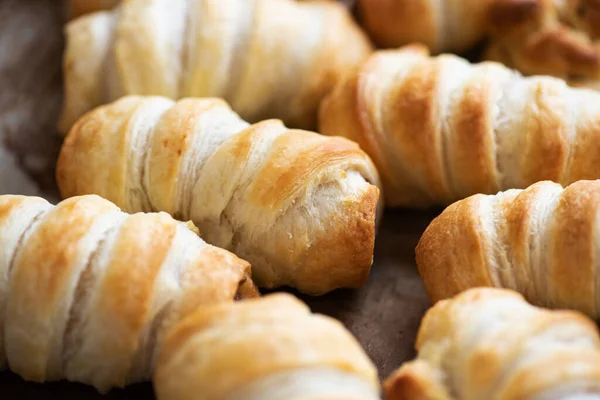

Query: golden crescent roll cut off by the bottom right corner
[[384, 288, 600, 400]]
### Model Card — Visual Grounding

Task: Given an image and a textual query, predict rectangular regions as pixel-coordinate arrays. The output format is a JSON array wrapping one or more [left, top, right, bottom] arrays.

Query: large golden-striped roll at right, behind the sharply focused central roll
[[320, 46, 600, 207]]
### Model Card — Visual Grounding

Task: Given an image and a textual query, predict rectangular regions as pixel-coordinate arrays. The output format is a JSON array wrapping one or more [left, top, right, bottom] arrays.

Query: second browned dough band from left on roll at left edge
[[3, 196, 118, 382]]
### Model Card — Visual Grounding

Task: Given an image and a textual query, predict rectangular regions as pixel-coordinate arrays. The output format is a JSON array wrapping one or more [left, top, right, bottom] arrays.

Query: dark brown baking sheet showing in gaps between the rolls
[[0, 0, 435, 400]]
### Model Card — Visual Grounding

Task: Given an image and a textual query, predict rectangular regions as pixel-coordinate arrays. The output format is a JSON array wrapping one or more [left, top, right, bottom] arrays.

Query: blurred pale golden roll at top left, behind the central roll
[[59, 0, 371, 132]]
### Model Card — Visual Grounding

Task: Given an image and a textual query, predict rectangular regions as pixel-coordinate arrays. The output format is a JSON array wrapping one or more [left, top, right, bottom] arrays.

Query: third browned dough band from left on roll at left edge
[[76, 214, 178, 386]]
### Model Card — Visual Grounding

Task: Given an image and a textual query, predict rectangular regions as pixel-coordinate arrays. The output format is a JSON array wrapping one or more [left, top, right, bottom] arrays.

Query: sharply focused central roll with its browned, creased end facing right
[[57, 96, 379, 294]]
